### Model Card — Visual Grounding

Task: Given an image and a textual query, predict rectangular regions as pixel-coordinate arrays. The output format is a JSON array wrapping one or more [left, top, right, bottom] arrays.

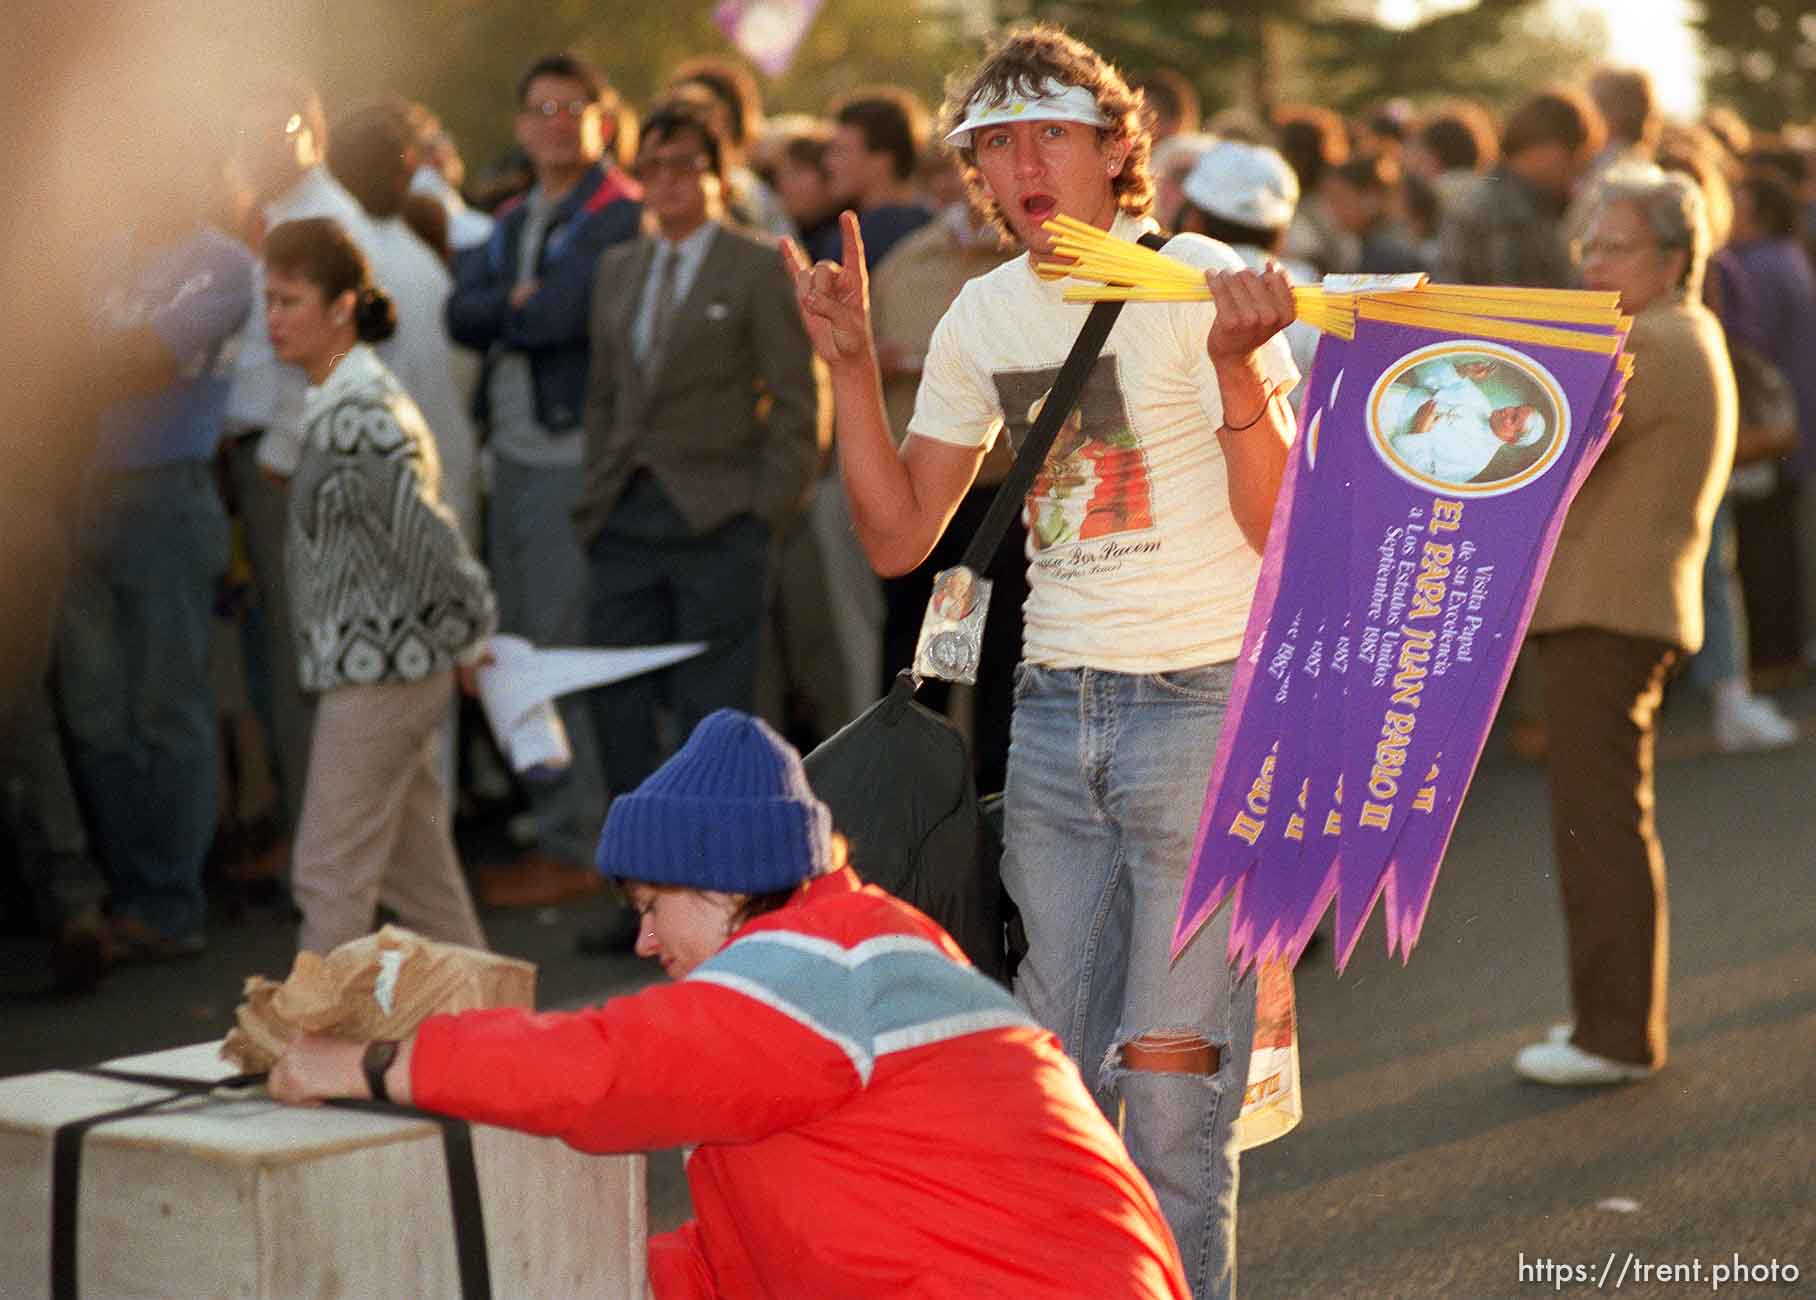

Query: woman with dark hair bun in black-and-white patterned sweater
[[265, 218, 496, 951]]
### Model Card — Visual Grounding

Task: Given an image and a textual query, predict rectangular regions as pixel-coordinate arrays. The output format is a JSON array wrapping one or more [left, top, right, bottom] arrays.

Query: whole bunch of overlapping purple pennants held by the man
[[1175, 299, 1620, 968]]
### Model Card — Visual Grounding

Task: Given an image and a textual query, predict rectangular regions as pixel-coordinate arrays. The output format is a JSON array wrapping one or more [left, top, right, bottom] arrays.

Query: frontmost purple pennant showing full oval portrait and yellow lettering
[[1333, 321, 1613, 964]]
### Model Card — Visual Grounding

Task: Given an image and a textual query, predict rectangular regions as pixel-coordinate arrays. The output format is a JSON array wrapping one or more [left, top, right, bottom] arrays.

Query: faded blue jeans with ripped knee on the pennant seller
[[1002, 665, 1255, 1300]]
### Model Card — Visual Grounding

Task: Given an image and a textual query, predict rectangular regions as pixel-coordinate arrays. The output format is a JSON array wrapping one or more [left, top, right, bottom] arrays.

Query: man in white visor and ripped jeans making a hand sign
[[786, 27, 1298, 1296]]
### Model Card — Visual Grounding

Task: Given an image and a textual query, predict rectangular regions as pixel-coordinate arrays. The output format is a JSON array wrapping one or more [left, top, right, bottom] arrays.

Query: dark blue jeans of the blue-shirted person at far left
[[58, 461, 227, 939]]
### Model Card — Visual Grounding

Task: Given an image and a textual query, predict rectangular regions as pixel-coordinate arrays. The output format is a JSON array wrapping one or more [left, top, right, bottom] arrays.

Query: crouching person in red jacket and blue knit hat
[[271, 710, 1188, 1300]]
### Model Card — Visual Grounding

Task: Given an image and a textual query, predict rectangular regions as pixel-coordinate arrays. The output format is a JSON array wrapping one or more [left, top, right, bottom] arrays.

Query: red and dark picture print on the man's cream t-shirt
[[990, 356, 1153, 559]]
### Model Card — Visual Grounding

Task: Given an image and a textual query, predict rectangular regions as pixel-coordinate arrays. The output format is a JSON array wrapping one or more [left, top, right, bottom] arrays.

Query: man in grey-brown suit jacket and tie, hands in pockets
[[574, 103, 830, 792]]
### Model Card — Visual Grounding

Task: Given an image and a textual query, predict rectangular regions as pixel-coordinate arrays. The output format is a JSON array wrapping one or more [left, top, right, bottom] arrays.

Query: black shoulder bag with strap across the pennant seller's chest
[[806, 234, 1164, 984]]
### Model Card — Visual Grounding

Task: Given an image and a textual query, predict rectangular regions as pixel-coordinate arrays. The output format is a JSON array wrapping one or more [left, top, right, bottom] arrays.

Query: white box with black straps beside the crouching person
[[0, 1042, 646, 1300]]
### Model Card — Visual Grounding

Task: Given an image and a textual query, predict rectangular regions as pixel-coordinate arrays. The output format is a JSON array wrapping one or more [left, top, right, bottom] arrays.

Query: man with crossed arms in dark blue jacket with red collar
[[447, 53, 643, 906]]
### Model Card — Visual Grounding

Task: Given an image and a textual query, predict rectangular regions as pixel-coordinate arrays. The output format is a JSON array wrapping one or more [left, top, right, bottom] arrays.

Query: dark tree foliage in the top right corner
[[1696, 0, 1816, 129]]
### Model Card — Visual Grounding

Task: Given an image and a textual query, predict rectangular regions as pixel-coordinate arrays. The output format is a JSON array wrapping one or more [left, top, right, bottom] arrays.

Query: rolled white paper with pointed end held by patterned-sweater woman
[[479, 635, 706, 773]]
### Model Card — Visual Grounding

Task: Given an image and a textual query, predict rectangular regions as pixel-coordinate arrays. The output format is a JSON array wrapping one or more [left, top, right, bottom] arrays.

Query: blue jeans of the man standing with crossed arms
[[487, 456, 605, 864]]
